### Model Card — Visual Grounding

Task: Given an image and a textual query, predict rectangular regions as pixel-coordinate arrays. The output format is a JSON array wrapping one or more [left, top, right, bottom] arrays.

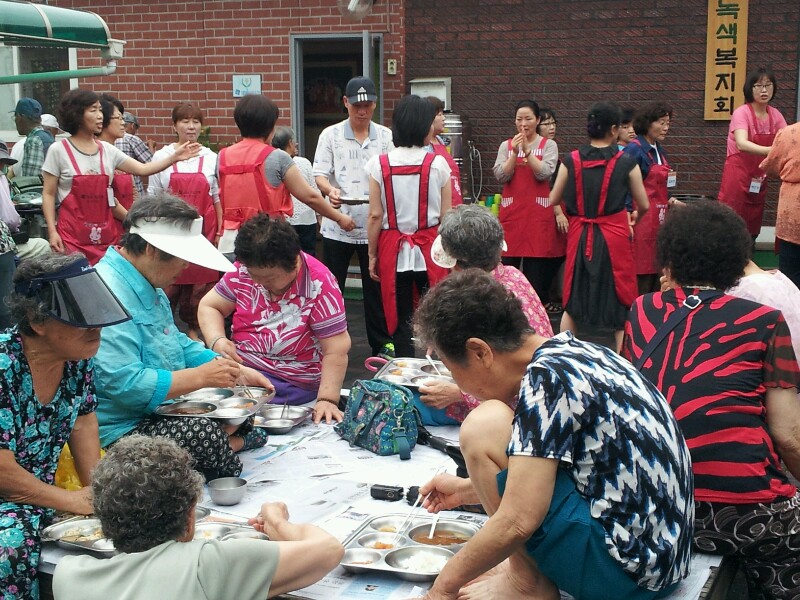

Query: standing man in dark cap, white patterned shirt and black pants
[[314, 77, 394, 358]]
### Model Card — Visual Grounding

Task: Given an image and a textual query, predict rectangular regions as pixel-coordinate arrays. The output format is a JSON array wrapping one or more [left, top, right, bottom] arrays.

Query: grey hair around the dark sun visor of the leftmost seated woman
[[6, 252, 86, 337]]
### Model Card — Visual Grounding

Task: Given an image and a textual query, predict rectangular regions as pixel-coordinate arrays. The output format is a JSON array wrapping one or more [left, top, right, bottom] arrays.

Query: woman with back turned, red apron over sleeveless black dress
[[551, 102, 649, 350]]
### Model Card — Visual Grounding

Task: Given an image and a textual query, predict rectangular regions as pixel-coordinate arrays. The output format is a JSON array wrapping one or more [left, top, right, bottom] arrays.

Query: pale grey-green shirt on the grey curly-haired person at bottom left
[[53, 539, 279, 600]]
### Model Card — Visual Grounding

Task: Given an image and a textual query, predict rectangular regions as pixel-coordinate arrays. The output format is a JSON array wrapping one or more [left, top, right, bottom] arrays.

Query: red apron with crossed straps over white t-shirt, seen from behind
[[378, 154, 448, 335]]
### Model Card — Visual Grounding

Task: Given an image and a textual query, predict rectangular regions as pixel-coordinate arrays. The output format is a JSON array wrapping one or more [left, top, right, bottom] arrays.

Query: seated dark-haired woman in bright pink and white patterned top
[[198, 213, 350, 423]]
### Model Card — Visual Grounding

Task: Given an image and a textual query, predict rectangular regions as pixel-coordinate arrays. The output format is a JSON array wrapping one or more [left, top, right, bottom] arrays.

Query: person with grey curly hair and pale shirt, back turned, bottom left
[[53, 435, 344, 600]]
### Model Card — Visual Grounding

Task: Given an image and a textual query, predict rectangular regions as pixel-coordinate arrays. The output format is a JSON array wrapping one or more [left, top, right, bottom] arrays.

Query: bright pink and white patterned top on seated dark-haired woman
[[214, 252, 347, 389]]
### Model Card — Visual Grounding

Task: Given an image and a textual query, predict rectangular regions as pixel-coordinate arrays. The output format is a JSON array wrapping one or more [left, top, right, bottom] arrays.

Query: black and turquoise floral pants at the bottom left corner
[[0, 502, 49, 600]]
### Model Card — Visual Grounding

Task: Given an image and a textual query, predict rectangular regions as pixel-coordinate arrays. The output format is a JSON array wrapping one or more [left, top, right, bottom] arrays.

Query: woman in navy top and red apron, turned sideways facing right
[[624, 102, 677, 294]]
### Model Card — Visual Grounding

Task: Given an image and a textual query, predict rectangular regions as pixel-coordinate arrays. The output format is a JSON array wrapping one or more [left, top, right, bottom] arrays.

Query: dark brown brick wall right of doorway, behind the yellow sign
[[405, 0, 800, 224]]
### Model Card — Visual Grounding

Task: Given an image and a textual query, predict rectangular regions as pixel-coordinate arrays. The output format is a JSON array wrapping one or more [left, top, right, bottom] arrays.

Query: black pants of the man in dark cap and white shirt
[[322, 237, 392, 354]]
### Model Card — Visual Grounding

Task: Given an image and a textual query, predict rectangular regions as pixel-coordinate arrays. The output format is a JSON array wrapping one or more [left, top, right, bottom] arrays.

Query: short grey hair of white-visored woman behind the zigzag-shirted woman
[[439, 204, 503, 271]]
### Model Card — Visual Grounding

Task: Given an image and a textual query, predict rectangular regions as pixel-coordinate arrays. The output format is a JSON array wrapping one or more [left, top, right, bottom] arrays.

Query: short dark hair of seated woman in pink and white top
[[238, 213, 300, 272]]
